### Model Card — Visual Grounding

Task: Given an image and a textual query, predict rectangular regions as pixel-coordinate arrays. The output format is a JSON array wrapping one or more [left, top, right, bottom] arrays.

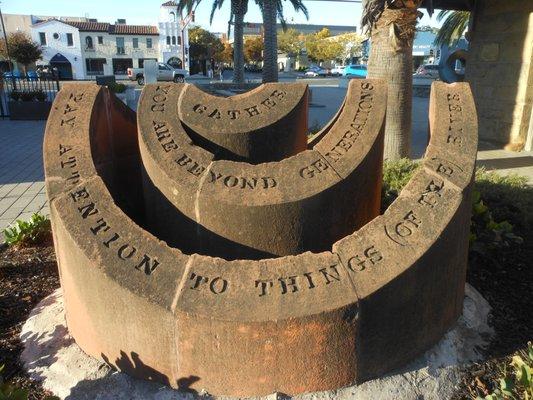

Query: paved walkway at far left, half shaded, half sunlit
[[0, 120, 50, 231]]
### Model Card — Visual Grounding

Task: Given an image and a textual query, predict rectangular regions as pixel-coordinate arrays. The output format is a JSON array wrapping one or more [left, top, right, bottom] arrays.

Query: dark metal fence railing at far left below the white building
[[0, 77, 60, 118]]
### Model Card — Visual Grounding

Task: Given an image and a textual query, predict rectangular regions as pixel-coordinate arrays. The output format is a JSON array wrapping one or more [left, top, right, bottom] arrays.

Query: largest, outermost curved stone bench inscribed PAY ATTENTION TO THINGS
[[44, 83, 477, 396]]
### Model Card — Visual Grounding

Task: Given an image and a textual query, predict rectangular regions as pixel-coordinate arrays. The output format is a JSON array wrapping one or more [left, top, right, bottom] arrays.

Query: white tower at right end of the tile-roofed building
[[159, 1, 189, 70]]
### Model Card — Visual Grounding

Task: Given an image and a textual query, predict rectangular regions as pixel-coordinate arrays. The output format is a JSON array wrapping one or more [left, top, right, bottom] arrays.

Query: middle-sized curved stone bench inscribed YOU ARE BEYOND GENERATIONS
[[138, 80, 386, 259]]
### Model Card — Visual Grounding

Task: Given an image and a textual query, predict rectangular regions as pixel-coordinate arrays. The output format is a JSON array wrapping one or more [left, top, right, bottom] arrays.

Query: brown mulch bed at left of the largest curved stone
[[0, 240, 59, 400]]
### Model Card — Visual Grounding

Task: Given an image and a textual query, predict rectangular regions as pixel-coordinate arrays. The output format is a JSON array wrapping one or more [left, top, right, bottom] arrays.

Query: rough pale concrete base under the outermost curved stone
[[21, 285, 493, 400]]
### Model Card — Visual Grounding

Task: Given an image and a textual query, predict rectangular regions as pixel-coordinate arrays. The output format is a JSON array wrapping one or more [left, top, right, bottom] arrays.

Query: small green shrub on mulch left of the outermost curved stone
[[4, 213, 50, 246]]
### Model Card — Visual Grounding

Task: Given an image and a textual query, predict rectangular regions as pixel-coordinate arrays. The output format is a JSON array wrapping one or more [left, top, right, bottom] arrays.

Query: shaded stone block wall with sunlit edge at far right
[[466, 0, 533, 150]]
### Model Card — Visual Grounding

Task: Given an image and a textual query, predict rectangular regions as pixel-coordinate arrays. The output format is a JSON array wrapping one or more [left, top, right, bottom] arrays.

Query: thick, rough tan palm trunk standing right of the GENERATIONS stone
[[361, 0, 421, 160]]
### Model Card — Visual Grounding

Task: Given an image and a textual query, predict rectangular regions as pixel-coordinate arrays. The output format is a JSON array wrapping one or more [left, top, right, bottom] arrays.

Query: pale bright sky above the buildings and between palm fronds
[[0, 0, 438, 32]]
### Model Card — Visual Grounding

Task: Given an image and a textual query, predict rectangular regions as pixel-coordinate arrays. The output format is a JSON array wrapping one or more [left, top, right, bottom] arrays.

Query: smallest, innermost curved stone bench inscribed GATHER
[[178, 83, 308, 164]]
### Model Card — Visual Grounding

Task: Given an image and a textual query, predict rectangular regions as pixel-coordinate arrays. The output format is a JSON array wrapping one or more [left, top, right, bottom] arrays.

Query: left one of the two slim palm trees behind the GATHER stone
[[178, 0, 248, 84]]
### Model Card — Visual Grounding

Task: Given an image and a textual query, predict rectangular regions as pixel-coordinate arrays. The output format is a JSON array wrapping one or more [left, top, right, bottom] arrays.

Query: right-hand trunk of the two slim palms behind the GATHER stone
[[262, 0, 278, 82]]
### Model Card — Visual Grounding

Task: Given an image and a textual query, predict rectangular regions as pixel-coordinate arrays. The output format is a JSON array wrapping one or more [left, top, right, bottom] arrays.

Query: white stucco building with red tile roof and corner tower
[[0, 1, 189, 80]]
